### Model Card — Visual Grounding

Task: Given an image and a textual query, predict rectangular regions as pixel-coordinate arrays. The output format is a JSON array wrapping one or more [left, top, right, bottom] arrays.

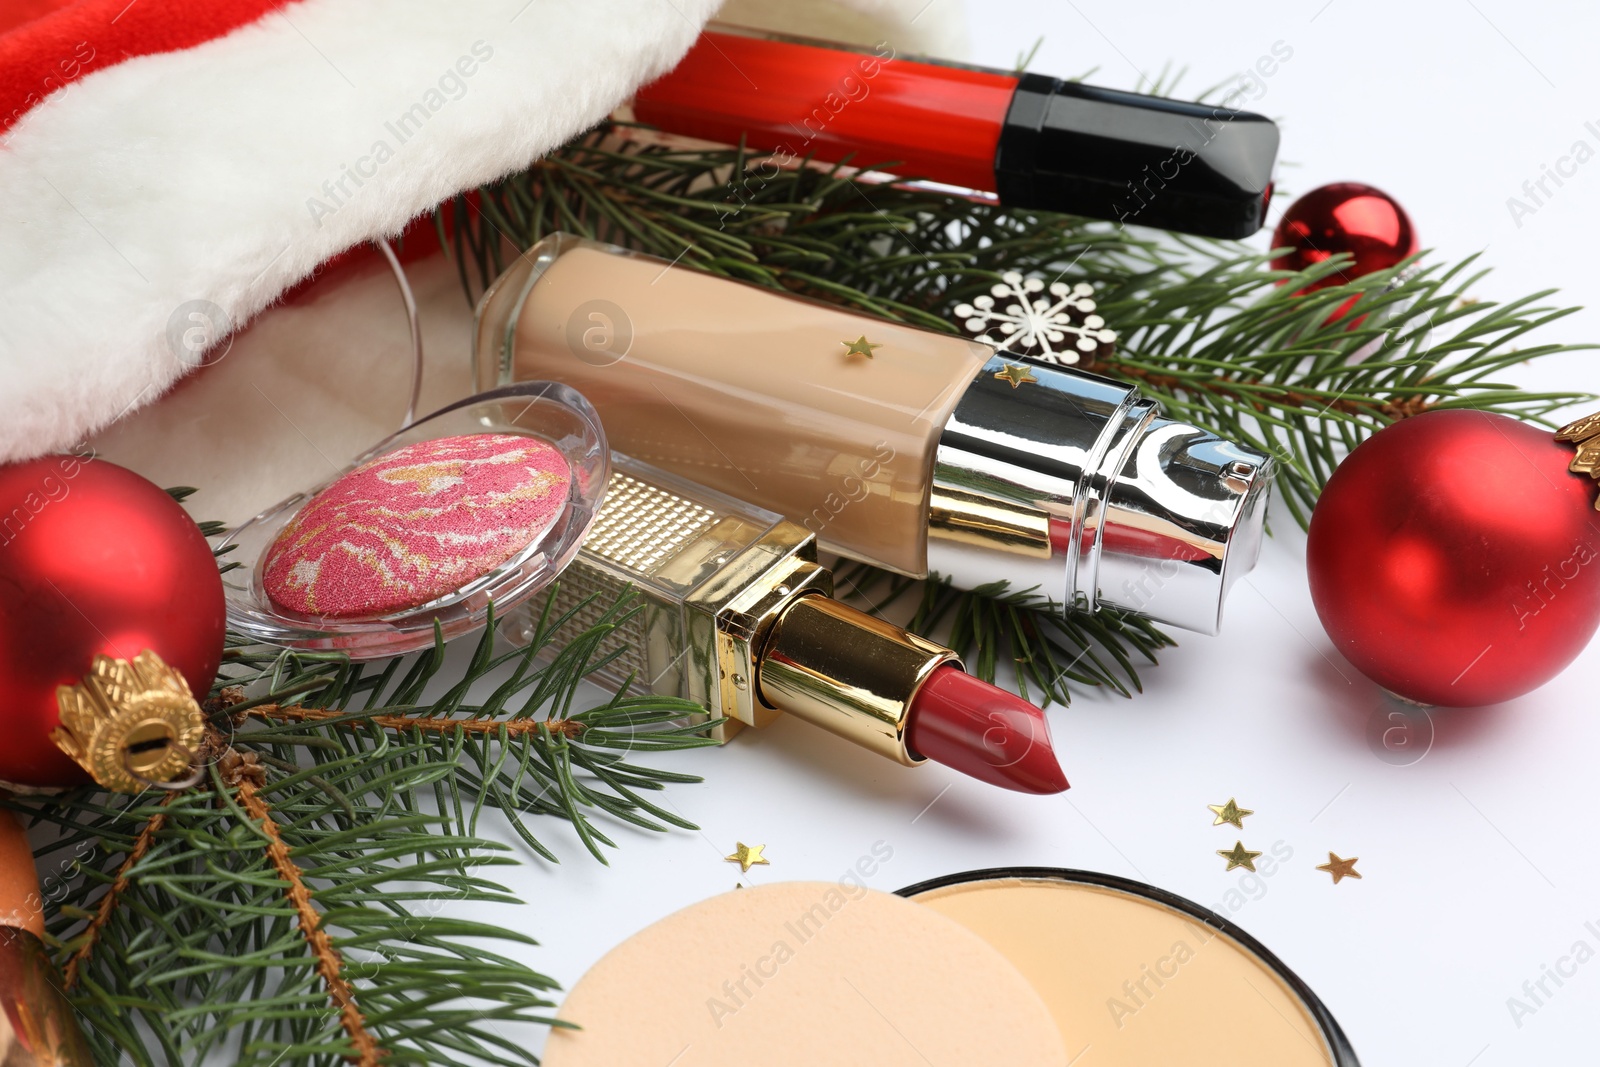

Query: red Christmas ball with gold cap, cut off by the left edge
[[0, 456, 226, 785]]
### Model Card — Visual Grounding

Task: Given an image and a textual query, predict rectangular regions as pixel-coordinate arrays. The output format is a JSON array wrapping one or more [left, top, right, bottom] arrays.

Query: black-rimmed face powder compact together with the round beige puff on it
[[542, 867, 1358, 1067]]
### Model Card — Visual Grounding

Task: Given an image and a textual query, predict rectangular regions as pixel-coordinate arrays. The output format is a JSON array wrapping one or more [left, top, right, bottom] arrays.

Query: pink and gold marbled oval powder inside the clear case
[[262, 434, 571, 619]]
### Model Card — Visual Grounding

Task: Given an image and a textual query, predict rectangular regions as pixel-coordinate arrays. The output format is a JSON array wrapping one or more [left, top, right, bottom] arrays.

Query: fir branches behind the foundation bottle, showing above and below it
[[442, 127, 1587, 702]]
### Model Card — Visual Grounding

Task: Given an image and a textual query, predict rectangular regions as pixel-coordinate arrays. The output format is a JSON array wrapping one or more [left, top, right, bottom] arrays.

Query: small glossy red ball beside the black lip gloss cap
[[1272, 182, 1418, 290]]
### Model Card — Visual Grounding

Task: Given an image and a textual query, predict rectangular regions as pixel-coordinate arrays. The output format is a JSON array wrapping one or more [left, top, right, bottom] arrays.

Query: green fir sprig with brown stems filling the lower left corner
[[5, 598, 712, 1067]]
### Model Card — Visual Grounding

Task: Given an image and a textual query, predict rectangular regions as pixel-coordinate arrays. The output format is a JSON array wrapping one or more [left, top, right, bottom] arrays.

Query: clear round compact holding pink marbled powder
[[219, 382, 610, 659]]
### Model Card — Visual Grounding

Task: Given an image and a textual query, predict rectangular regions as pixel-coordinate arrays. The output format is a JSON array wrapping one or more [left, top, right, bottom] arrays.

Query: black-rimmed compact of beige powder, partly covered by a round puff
[[901, 867, 1357, 1067]]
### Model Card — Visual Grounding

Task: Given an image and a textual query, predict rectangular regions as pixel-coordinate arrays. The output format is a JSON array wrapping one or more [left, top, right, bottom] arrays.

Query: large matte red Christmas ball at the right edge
[[1306, 411, 1600, 707]]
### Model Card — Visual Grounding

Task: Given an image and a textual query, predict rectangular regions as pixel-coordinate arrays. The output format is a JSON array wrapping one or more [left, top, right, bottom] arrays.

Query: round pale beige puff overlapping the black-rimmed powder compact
[[544, 881, 1067, 1067]]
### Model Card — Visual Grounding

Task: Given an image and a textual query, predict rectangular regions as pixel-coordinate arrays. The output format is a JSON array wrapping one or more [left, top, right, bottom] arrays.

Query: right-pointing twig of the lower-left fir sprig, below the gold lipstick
[[226, 592, 715, 862]]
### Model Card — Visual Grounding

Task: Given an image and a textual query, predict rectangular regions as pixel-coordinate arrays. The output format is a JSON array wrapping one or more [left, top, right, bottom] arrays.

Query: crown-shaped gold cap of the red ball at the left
[[51, 649, 205, 793]]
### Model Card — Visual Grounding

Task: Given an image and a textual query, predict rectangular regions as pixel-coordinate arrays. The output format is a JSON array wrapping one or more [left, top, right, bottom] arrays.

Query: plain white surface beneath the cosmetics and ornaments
[[93, 0, 1600, 1067]]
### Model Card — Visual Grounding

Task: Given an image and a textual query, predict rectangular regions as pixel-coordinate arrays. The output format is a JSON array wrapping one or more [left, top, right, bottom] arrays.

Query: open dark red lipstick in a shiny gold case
[[524, 454, 1067, 793]]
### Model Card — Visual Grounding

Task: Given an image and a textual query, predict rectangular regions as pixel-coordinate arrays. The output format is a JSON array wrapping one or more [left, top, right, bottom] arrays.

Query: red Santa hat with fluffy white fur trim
[[0, 0, 958, 462]]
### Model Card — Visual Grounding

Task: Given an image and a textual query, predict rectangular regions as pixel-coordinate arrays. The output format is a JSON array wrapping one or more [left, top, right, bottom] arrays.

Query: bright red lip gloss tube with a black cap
[[632, 26, 1278, 237]]
